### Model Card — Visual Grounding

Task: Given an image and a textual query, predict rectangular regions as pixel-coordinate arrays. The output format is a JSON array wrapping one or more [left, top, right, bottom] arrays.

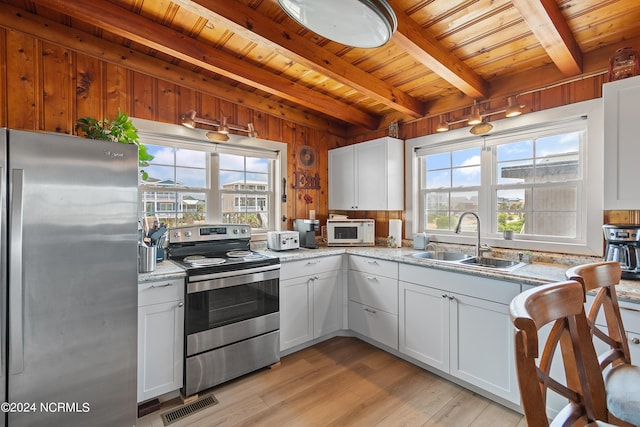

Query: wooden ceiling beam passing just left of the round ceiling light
[[173, 0, 424, 117]]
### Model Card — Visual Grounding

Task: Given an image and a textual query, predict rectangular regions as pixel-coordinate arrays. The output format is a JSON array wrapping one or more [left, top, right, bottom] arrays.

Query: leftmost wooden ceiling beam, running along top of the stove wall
[[0, 4, 346, 137]]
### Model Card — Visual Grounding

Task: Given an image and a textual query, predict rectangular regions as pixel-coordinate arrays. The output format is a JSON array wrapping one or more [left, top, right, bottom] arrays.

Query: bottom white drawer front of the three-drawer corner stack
[[349, 301, 398, 350]]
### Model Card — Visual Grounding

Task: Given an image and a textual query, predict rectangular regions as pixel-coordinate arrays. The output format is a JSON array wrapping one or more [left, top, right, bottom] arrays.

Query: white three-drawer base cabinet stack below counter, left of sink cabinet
[[348, 255, 398, 350]]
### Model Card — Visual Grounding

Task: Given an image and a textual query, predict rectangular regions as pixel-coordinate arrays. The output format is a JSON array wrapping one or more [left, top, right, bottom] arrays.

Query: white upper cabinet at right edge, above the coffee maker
[[602, 76, 640, 210]]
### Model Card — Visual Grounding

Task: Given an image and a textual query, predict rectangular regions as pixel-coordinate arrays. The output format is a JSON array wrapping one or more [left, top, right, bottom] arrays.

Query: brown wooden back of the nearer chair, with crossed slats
[[510, 281, 607, 427]]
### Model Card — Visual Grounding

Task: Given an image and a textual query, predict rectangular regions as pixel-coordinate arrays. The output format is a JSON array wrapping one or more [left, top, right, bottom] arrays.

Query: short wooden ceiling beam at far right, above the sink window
[[512, 0, 582, 76]]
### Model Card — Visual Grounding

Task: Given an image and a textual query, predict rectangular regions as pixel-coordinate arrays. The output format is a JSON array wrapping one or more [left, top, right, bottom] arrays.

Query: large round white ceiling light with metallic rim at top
[[278, 0, 398, 48]]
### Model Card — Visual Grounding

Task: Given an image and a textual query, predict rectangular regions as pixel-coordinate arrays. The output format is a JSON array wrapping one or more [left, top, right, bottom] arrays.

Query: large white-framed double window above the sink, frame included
[[406, 100, 604, 255]]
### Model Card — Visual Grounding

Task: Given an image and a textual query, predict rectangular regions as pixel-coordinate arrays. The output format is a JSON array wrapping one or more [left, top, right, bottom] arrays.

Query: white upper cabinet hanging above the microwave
[[329, 137, 404, 211]]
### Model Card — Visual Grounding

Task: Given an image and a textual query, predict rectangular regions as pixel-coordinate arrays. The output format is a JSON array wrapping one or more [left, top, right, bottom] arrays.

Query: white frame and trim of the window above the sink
[[405, 99, 604, 256]]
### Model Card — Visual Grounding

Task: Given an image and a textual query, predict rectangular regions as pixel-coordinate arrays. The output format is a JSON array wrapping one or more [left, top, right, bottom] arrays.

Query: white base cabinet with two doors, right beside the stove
[[280, 255, 342, 351]]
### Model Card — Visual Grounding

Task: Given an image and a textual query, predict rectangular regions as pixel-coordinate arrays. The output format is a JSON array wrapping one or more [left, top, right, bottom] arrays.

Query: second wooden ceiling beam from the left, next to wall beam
[[32, 0, 379, 129]]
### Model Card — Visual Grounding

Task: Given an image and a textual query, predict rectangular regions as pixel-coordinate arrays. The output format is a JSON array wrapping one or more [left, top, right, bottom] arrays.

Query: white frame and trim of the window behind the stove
[[132, 118, 288, 240]]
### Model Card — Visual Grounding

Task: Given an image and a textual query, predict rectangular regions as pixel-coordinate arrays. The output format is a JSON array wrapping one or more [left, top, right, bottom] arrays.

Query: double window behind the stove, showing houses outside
[[140, 138, 286, 234]]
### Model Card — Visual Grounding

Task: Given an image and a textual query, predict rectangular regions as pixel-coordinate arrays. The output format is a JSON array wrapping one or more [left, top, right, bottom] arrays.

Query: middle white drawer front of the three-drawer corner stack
[[348, 270, 398, 314]]
